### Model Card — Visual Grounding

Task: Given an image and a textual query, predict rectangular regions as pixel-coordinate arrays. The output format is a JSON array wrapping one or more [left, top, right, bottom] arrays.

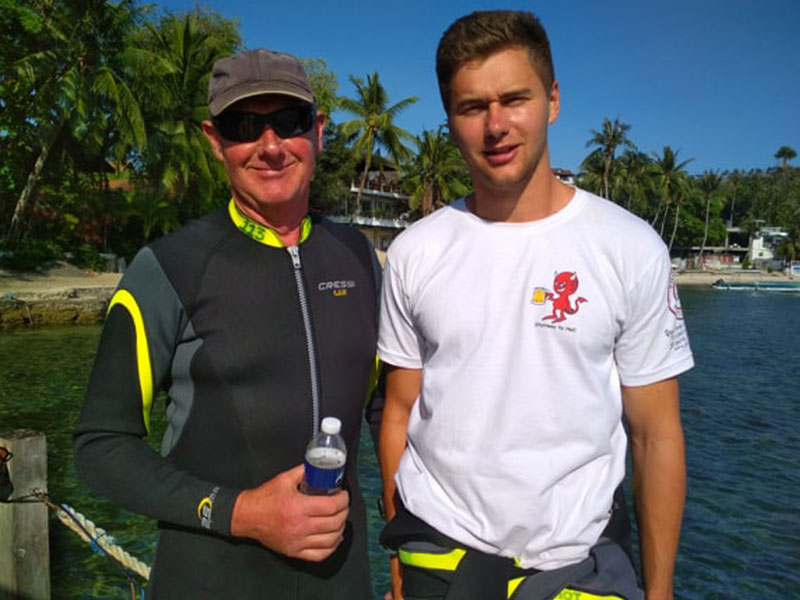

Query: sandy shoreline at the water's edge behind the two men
[[0, 261, 798, 330]]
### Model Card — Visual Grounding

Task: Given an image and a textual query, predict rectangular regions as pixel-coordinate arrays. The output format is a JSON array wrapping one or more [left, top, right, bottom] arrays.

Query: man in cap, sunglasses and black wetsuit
[[75, 50, 379, 600]]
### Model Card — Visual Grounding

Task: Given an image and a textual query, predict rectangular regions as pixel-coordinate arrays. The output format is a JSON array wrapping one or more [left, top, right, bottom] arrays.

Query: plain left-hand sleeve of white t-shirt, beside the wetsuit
[[378, 259, 423, 369]]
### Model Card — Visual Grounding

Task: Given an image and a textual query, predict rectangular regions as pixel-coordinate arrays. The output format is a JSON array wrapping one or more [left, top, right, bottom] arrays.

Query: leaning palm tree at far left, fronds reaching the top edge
[[5, 0, 146, 245]]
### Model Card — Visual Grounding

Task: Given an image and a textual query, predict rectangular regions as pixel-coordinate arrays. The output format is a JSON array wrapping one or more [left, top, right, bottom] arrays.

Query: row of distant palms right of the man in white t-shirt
[[577, 118, 800, 264]]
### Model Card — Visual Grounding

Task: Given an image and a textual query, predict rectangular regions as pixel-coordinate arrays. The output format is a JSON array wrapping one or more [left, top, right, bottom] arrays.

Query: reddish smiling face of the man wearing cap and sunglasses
[[203, 95, 325, 214]]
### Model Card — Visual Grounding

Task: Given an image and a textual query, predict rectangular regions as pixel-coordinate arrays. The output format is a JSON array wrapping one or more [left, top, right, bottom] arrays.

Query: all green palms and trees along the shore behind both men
[[0, 0, 800, 274]]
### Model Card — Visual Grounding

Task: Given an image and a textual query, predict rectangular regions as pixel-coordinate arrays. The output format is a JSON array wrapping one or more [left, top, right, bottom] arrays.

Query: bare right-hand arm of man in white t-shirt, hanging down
[[622, 377, 686, 600]]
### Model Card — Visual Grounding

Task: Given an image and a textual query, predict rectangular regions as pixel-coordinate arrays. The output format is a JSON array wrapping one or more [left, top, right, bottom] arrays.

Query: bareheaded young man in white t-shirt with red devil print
[[378, 11, 693, 600]]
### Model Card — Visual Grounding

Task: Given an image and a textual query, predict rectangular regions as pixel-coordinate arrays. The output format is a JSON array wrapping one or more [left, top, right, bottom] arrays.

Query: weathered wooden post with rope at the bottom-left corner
[[0, 429, 50, 600]]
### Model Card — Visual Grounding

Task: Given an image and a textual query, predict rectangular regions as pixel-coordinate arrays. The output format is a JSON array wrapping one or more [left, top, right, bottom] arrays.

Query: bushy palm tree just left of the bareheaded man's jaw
[[405, 125, 469, 217]]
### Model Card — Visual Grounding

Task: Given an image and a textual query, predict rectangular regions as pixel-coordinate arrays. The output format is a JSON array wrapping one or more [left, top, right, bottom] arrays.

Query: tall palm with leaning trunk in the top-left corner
[[2, 0, 145, 243]]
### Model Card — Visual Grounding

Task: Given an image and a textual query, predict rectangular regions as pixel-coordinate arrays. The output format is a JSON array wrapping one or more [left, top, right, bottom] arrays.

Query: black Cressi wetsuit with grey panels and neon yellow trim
[[75, 205, 379, 600]]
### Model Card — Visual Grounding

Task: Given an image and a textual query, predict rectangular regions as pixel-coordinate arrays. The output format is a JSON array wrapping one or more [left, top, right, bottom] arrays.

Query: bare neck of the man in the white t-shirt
[[467, 163, 575, 223]]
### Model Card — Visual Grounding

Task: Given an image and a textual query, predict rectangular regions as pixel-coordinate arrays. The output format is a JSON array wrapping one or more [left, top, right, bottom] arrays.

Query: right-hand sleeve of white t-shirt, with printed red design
[[614, 248, 694, 386]]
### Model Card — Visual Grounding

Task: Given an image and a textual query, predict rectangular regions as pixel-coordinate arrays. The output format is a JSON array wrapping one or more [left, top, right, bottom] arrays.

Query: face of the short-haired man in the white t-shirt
[[448, 48, 559, 194]]
